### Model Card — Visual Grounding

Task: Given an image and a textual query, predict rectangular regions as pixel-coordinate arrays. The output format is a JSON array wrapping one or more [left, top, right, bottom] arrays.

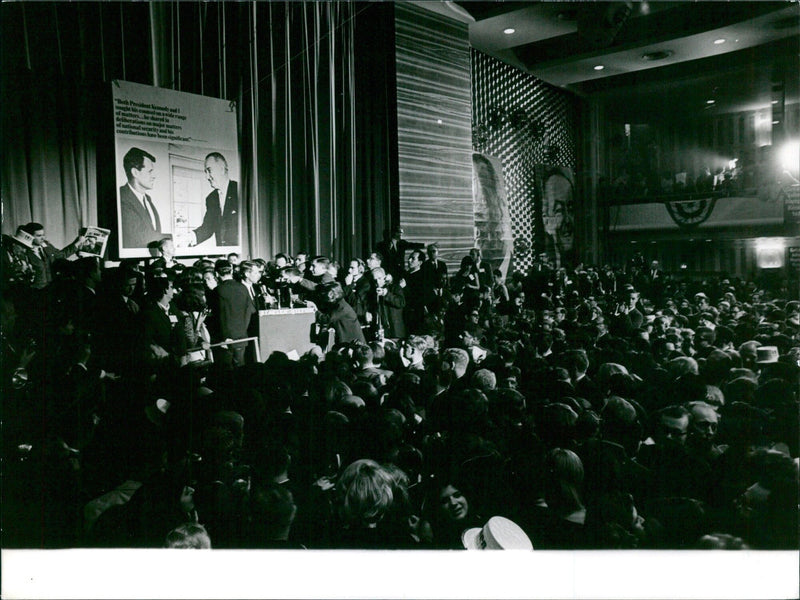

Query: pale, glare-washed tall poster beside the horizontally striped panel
[[472, 152, 513, 277]]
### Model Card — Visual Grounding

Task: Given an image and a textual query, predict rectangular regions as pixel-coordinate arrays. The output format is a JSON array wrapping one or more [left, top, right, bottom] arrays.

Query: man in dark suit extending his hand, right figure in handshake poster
[[189, 152, 239, 251]]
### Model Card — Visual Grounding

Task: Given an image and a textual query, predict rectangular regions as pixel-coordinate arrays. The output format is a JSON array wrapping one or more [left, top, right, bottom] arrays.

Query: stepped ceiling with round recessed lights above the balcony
[[440, 0, 800, 120]]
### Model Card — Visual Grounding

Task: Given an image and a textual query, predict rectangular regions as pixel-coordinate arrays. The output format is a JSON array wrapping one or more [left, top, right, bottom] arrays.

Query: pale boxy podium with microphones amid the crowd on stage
[[258, 308, 316, 361]]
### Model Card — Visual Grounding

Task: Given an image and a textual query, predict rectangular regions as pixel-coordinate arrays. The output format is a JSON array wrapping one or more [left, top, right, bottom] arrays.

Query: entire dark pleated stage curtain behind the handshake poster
[[0, 2, 397, 260]]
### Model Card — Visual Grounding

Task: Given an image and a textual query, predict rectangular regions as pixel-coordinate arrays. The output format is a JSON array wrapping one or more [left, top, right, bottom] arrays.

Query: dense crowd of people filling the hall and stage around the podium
[[2, 223, 800, 550]]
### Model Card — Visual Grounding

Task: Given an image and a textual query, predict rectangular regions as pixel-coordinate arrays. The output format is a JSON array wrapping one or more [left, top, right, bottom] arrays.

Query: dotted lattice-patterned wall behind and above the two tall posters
[[472, 50, 579, 272]]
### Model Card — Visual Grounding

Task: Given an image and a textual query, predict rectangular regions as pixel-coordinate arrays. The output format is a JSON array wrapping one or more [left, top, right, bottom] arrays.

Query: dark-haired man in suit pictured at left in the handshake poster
[[119, 148, 161, 248]]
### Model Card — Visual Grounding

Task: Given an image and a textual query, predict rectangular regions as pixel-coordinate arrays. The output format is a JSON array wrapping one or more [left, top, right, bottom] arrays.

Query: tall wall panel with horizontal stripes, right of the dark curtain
[[395, 2, 474, 271]]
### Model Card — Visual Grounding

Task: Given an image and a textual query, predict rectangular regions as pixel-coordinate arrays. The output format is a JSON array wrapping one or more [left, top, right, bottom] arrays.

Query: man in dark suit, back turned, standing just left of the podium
[[208, 260, 256, 367]]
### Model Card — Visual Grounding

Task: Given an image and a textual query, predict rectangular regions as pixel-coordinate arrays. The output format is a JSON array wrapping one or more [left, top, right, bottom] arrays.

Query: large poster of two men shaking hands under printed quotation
[[112, 81, 243, 258]]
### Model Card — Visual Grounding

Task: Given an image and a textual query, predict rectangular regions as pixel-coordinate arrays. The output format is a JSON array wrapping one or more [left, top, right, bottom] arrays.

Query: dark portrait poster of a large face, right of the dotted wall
[[534, 165, 575, 267]]
